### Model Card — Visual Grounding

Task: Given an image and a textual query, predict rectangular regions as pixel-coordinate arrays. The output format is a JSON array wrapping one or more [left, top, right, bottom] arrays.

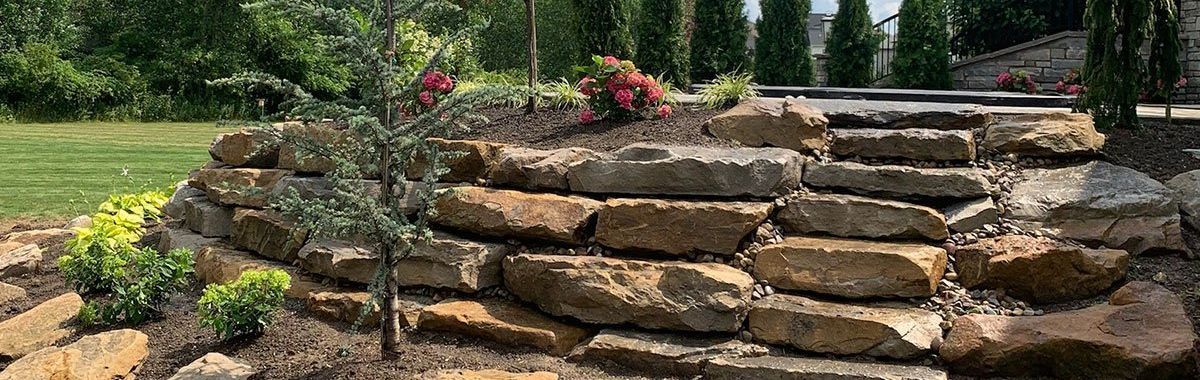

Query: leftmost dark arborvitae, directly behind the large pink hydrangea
[[575, 0, 634, 59]]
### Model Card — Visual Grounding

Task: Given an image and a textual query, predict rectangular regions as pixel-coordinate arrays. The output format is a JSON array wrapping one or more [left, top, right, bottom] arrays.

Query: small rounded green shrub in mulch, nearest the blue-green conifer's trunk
[[197, 270, 292, 339]]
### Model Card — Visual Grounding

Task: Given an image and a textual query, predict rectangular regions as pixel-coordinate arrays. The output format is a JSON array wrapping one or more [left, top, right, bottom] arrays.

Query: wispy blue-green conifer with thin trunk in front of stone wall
[[215, 0, 530, 357]]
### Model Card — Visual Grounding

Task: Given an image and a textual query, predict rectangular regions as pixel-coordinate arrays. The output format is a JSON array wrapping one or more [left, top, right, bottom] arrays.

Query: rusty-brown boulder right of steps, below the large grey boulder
[[954, 235, 1129, 303]]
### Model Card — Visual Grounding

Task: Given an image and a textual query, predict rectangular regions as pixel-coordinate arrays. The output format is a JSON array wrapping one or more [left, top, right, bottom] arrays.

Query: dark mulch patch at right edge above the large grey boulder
[[1104, 121, 1200, 181]]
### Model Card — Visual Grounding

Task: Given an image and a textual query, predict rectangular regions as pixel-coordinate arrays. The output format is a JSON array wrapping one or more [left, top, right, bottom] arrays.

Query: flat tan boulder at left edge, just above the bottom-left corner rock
[[0, 292, 83, 360]]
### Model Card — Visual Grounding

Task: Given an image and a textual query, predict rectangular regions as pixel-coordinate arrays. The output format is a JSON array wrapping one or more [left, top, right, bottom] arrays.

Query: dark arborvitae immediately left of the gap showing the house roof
[[754, 0, 816, 86]]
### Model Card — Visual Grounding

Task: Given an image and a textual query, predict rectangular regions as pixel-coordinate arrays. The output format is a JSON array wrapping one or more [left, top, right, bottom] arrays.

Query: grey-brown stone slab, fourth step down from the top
[[775, 193, 950, 240]]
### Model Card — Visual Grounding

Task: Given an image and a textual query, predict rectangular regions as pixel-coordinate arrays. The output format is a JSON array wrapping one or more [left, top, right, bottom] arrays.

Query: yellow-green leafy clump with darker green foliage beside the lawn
[[59, 191, 193, 325]]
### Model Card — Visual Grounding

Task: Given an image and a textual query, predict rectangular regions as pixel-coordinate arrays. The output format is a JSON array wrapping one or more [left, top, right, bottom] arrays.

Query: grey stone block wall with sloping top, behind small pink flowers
[[950, 31, 1087, 91]]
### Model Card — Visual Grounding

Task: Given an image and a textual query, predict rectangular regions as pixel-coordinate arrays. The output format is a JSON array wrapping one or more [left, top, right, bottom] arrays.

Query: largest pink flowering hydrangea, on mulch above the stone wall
[[575, 55, 672, 123]]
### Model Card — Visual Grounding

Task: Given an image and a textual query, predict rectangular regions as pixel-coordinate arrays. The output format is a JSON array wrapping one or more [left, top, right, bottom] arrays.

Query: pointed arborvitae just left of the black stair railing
[[826, 0, 880, 88]]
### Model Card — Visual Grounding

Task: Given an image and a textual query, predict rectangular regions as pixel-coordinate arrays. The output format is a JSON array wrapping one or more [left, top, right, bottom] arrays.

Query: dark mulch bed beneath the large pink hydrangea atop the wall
[[455, 107, 733, 151]]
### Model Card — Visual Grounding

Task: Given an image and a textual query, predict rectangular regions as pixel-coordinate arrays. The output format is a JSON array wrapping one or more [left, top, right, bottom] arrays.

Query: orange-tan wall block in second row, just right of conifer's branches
[[432, 187, 604, 245]]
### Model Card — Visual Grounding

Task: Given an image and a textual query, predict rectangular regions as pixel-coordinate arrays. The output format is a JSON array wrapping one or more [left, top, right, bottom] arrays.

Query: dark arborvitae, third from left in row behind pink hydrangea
[[691, 0, 750, 82]]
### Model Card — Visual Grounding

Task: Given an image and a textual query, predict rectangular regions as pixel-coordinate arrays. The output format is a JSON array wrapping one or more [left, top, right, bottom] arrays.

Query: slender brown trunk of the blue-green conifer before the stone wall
[[379, 0, 401, 358]]
